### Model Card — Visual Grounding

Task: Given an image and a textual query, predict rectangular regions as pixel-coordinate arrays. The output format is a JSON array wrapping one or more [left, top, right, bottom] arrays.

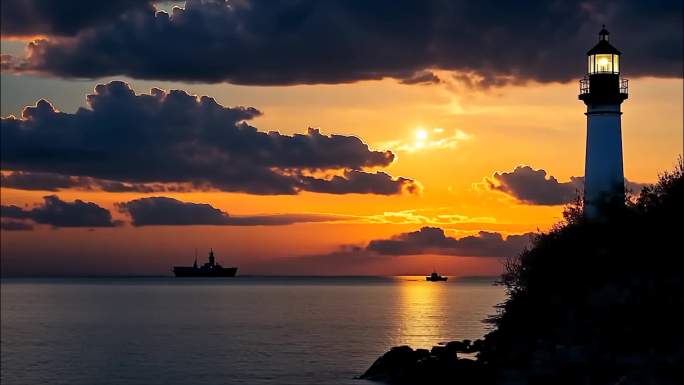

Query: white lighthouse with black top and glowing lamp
[[578, 26, 627, 219]]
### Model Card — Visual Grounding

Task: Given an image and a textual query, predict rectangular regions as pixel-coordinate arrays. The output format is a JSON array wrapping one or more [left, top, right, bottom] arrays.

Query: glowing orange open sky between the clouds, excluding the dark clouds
[[1, 59, 683, 275]]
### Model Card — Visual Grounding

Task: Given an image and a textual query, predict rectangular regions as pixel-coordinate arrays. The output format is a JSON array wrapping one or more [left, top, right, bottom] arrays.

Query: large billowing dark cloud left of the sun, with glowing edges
[[0, 82, 417, 194]]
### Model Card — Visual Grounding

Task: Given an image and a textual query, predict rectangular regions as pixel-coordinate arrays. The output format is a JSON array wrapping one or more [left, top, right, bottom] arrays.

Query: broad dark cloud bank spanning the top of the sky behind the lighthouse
[[3, 0, 683, 85]]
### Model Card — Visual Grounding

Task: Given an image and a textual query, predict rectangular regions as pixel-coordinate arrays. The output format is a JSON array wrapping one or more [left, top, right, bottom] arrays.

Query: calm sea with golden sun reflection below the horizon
[[0, 277, 504, 385]]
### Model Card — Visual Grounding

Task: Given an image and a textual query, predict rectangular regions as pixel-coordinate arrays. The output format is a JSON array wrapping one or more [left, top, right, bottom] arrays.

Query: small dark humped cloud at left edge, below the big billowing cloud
[[0, 195, 118, 227]]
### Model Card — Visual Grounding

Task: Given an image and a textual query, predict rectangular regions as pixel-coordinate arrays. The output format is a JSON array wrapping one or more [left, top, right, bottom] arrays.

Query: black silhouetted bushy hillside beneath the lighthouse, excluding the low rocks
[[479, 158, 684, 384]]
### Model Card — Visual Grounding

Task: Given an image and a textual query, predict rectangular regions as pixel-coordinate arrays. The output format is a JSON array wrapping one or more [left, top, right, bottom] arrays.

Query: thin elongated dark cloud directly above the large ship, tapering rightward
[[117, 197, 345, 226]]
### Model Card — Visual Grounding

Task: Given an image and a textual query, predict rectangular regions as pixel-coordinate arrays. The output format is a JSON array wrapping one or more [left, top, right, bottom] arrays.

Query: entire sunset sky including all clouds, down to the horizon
[[1, 0, 684, 276]]
